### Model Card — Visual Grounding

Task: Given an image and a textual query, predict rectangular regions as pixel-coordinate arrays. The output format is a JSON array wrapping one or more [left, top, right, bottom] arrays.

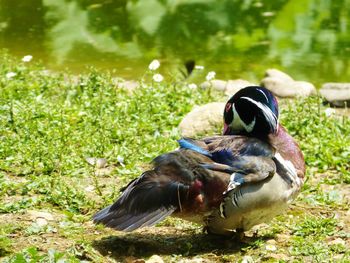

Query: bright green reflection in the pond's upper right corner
[[268, 0, 350, 79]]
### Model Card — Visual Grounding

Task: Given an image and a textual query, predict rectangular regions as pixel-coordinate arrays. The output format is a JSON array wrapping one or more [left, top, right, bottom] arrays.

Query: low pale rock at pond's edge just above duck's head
[[200, 79, 256, 96]]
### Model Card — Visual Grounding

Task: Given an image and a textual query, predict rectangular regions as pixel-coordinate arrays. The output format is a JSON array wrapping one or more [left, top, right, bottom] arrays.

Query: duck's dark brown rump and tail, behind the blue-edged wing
[[93, 149, 224, 231]]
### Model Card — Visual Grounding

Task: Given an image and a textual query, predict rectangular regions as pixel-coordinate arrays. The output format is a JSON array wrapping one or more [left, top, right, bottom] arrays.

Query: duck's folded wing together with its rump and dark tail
[[93, 136, 271, 231]]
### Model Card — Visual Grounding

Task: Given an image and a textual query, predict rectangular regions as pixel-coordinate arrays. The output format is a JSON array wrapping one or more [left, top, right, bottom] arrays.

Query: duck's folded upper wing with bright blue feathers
[[179, 136, 276, 189]]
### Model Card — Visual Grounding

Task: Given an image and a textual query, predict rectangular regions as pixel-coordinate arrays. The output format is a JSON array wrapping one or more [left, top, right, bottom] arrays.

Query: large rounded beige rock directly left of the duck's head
[[179, 102, 225, 137]]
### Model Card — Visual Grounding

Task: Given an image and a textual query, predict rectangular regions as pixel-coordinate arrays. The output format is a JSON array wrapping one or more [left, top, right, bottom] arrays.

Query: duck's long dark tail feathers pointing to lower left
[[93, 170, 189, 231]]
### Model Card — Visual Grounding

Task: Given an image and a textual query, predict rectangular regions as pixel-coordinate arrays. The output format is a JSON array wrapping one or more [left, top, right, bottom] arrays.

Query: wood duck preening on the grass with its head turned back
[[93, 86, 305, 235]]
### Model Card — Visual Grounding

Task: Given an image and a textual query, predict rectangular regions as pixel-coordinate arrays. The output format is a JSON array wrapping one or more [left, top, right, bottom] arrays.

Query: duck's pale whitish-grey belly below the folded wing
[[207, 173, 298, 234]]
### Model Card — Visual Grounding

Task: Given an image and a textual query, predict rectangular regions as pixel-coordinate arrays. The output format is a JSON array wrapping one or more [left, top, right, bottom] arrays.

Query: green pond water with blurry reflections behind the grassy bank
[[0, 0, 350, 85]]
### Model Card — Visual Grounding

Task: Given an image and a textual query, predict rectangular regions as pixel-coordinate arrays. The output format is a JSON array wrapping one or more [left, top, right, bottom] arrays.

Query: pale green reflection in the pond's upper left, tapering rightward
[[44, 0, 140, 62]]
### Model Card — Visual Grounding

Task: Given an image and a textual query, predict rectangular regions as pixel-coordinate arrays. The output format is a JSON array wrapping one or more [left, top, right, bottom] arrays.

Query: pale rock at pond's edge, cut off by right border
[[320, 83, 350, 107]]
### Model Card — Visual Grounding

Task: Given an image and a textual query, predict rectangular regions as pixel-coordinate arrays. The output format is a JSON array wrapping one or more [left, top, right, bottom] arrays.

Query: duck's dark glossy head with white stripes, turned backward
[[223, 86, 278, 137]]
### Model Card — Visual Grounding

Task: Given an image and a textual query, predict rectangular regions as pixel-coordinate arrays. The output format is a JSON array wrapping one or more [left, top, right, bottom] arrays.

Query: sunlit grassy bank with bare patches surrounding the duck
[[0, 53, 350, 262]]
